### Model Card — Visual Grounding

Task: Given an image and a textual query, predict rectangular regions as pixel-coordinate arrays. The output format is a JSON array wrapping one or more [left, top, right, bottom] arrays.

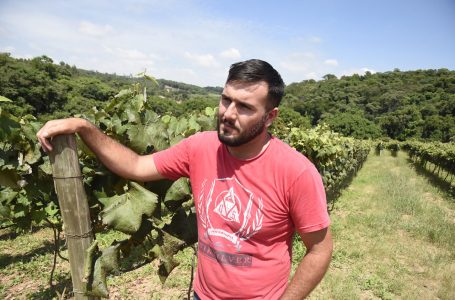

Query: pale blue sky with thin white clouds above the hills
[[0, 0, 455, 86]]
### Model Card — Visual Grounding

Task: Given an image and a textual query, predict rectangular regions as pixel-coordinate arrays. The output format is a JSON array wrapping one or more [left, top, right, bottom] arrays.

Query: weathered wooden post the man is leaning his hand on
[[50, 134, 95, 300]]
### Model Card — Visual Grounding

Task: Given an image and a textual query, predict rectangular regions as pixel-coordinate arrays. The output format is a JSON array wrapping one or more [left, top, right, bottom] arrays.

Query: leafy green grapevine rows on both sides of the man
[[0, 84, 455, 297]]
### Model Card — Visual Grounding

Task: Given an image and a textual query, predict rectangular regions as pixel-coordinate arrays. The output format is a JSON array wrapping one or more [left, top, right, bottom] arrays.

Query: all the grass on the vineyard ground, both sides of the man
[[0, 151, 455, 299]]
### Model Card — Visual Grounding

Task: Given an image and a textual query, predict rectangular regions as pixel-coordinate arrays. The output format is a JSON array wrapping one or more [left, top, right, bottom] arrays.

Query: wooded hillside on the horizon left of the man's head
[[0, 53, 222, 117]]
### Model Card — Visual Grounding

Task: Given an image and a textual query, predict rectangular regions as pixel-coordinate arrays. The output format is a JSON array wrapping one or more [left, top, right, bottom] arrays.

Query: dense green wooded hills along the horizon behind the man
[[0, 53, 455, 142]]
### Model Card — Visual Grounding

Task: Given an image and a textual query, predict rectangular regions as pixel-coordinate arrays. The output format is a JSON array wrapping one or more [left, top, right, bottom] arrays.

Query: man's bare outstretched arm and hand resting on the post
[[36, 118, 164, 181]]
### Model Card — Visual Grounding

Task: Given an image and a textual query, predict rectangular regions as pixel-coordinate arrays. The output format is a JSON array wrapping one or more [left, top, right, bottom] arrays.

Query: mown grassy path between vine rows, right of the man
[[311, 152, 455, 299]]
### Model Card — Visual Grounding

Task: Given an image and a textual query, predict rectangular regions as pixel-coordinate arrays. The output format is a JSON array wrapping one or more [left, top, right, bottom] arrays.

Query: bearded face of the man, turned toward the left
[[217, 81, 270, 147]]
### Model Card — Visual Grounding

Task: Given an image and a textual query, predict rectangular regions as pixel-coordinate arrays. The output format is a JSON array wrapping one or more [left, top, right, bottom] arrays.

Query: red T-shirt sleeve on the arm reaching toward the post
[[152, 136, 192, 180]]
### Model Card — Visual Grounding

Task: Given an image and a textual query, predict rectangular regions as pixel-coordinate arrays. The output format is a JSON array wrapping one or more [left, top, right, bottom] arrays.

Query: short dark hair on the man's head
[[226, 59, 284, 109]]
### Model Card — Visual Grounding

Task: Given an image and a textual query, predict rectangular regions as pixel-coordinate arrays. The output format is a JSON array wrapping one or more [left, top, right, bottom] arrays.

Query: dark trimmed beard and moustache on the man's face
[[216, 114, 267, 147]]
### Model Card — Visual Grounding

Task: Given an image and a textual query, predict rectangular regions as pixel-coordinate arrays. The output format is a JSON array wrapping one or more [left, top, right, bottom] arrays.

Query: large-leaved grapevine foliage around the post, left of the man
[[0, 79, 216, 297]]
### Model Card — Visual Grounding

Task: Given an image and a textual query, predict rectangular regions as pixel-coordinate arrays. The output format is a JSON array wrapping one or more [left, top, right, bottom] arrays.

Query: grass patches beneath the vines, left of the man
[[0, 228, 193, 299]]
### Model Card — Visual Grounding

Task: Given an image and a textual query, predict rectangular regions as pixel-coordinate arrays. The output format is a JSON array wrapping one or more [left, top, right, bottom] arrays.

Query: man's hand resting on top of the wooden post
[[36, 118, 88, 152]]
